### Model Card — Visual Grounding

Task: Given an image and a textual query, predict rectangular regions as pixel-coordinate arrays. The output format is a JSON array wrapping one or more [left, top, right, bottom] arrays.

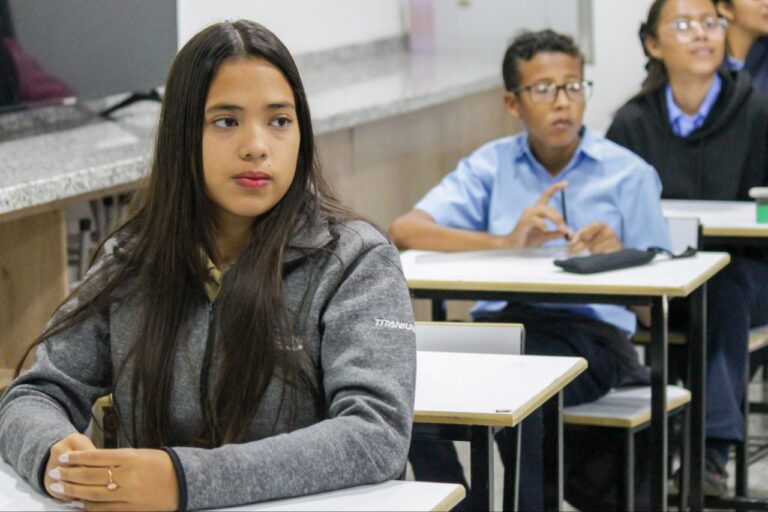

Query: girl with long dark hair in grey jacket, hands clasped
[[0, 20, 415, 510]]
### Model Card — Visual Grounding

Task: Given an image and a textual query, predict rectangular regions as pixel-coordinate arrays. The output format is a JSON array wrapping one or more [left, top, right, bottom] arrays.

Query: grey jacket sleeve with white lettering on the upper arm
[[171, 244, 416, 509]]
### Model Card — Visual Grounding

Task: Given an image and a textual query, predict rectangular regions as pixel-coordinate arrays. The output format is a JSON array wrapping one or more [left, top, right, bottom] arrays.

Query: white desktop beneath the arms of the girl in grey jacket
[[0, 462, 465, 512]]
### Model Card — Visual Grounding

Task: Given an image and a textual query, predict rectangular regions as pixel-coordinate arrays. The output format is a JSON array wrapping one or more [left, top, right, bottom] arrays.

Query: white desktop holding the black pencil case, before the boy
[[400, 249, 730, 297]]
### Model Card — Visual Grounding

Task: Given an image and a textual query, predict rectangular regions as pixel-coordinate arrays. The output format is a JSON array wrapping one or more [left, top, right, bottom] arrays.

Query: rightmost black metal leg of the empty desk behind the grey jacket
[[543, 393, 563, 510]]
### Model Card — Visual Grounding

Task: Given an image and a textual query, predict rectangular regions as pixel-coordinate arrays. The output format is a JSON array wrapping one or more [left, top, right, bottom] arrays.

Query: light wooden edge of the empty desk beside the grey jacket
[[413, 357, 587, 427]]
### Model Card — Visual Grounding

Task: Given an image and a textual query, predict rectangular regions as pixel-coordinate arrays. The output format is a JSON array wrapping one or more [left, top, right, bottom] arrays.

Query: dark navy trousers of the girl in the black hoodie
[[670, 256, 768, 441]]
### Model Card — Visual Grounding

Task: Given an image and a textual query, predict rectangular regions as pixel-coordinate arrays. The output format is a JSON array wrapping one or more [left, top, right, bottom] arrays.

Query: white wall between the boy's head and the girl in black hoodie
[[586, 0, 652, 132]]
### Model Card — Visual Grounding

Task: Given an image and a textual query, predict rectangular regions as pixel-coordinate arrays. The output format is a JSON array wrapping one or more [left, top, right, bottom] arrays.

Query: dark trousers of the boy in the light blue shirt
[[409, 306, 647, 510]]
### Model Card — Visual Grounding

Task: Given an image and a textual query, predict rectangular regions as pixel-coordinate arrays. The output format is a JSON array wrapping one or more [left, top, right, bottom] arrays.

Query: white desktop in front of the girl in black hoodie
[[661, 199, 768, 237]]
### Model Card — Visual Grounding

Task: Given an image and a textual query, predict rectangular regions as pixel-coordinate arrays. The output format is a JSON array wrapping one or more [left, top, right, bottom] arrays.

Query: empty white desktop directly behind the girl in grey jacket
[[414, 351, 587, 426]]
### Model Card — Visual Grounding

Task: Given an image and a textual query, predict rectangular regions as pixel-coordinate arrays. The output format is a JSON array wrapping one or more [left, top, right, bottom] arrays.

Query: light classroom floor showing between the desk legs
[[408, 374, 768, 511]]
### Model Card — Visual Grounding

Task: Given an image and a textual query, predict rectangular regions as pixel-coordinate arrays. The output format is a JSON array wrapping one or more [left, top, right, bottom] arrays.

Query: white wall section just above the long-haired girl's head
[[178, 0, 408, 55]]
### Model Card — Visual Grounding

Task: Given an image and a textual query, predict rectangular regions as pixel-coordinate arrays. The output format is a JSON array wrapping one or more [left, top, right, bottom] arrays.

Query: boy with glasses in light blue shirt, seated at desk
[[390, 30, 669, 510]]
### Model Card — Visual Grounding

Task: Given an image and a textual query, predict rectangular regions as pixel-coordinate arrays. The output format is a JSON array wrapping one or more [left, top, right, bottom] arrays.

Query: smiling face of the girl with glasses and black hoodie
[[645, 0, 725, 78]]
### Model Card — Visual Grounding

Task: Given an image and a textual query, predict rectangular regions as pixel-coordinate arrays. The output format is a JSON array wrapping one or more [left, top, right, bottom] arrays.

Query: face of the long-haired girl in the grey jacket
[[203, 58, 301, 227]]
